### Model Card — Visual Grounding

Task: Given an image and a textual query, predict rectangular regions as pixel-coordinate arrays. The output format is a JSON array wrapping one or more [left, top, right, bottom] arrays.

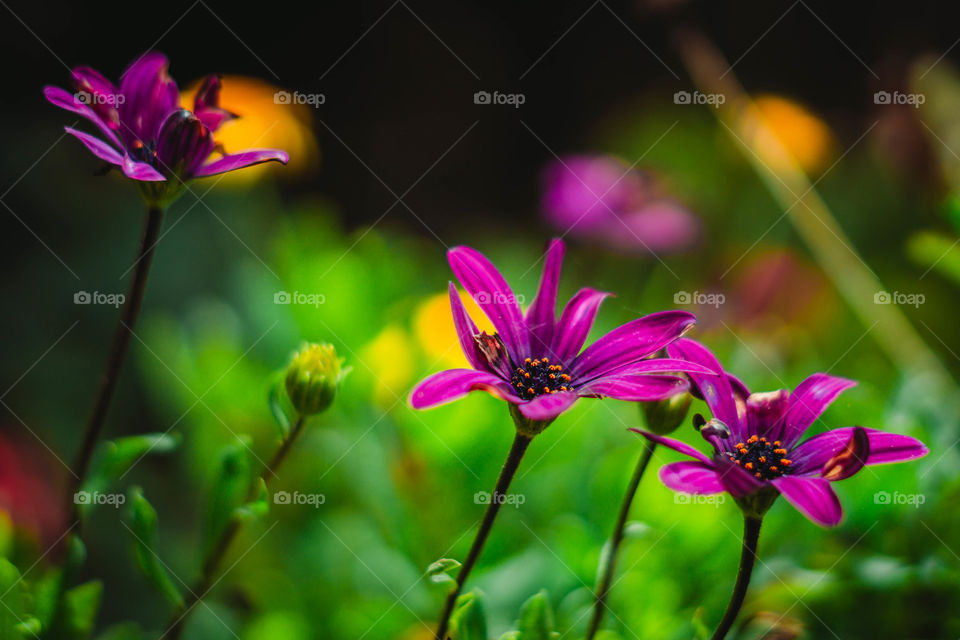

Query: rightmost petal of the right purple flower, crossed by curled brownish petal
[[790, 427, 929, 475]]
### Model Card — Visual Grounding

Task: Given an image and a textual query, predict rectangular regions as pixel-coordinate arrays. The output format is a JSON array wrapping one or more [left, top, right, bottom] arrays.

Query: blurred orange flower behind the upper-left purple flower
[[181, 75, 320, 184]]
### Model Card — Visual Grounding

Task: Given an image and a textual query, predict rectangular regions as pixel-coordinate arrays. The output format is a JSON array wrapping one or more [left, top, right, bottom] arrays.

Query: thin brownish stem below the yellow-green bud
[[160, 416, 306, 640]]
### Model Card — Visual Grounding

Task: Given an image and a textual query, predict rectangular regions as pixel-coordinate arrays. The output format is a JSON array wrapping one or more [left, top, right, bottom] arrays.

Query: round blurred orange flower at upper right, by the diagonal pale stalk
[[745, 95, 834, 174]]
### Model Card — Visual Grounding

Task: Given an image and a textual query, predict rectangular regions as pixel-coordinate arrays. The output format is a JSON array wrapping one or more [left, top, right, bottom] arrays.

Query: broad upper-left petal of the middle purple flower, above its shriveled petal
[[447, 247, 529, 362]]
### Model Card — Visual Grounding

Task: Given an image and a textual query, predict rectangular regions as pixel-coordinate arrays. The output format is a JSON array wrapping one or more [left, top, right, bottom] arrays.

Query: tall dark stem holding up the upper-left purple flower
[[68, 206, 163, 525]]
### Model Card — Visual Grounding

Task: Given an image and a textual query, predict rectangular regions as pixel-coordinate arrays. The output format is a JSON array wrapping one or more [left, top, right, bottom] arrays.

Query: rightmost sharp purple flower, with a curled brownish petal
[[634, 339, 927, 527]]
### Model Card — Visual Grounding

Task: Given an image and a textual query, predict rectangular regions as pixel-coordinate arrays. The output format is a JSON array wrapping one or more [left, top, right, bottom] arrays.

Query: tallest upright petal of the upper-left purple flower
[[119, 51, 180, 144]]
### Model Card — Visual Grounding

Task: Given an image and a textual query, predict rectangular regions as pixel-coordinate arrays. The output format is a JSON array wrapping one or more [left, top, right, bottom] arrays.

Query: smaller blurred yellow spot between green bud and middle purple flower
[[357, 325, 416, 407]]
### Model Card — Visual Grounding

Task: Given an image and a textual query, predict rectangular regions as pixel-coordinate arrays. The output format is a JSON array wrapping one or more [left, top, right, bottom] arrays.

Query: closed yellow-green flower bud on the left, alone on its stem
[[286, 343, 347, 416]]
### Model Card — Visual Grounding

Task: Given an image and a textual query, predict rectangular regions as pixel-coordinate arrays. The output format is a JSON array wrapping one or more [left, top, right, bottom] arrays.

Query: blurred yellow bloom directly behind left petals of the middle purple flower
[[413, 291, 495, 368]]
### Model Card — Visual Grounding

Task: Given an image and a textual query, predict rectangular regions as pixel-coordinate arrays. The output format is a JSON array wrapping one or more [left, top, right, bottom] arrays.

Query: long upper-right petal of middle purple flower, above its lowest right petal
[[570, 311, 697, 384]]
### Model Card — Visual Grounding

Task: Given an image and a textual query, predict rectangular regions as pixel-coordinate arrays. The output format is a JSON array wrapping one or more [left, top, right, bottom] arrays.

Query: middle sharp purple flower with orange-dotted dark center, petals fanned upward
[[410, 239, 711, 423]]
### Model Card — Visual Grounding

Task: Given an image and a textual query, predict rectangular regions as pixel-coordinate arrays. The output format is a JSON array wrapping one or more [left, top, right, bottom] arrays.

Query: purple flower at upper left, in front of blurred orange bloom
[[43, 52, 288, 193]]
